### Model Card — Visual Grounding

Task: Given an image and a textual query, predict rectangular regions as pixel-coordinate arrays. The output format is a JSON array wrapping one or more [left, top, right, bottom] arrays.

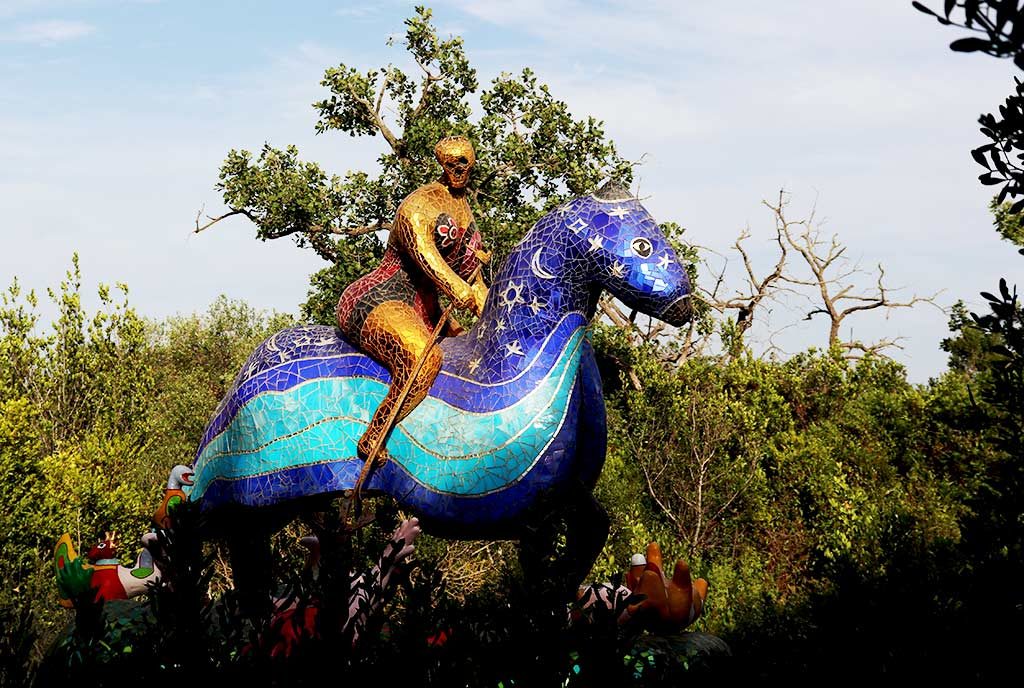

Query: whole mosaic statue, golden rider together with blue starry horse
[[177, 147, 690, 606]]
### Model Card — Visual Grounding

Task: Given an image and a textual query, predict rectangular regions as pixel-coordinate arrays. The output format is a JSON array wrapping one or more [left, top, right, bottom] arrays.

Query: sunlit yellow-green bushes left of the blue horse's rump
[[0, 264, 291, 673]]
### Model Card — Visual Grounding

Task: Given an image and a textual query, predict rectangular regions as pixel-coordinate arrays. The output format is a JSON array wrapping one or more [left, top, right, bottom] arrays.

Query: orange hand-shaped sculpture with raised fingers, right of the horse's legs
[[626, 543, 708, 631]]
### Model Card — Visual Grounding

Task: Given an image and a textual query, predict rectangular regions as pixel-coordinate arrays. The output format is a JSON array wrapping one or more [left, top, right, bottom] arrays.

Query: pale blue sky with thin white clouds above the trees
[[0, 0, 1021, 382]]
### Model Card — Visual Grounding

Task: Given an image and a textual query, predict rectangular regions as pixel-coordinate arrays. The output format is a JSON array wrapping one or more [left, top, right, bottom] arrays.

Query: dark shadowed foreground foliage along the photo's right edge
[[913, 0, 1024, 675]]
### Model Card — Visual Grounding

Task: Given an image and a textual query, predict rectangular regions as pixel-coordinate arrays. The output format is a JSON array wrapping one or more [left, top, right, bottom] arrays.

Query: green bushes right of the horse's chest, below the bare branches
[[595, 331, 989, 649]]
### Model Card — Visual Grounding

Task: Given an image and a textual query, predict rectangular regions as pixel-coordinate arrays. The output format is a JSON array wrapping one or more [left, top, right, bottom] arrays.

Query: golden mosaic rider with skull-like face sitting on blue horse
[[336, 136, 487, 465]]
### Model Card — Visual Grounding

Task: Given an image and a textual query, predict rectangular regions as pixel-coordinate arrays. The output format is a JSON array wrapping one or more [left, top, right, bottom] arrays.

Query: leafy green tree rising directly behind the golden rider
[[196, 6, 632, 323]]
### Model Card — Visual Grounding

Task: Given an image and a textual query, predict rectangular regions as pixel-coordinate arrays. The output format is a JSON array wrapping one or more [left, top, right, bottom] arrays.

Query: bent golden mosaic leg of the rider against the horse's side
[[358, 301, 442, 463]]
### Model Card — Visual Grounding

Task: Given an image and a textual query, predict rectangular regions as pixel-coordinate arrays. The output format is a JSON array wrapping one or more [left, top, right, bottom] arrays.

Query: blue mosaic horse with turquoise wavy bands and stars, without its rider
[[187, 183, 690, 577]]
